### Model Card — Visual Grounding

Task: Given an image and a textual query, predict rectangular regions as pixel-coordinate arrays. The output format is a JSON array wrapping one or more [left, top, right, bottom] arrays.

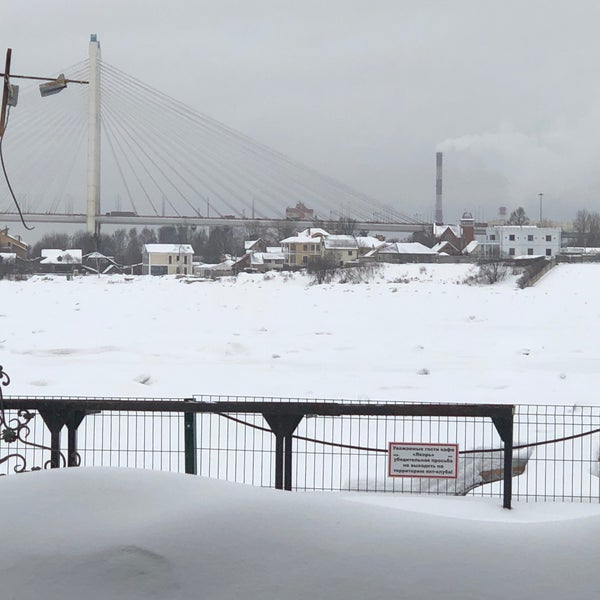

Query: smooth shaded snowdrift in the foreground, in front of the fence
[[0, 469, 600, 600]]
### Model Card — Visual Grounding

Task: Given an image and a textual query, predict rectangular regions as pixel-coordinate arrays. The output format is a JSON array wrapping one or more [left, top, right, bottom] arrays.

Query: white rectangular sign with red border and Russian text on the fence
[[388, 442, 458, 479]]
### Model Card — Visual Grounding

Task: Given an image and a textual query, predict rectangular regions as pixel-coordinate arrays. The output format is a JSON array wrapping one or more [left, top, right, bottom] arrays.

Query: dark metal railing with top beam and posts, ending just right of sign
[[2, 384, 513, 507]]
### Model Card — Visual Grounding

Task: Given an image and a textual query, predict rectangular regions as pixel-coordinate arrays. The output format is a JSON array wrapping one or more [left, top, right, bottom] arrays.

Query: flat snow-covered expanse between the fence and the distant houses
[[0, 265, 600, 405]]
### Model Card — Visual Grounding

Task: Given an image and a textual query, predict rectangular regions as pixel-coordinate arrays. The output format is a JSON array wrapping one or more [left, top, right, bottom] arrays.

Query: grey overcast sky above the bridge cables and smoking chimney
[[0, 0, 600, 222]]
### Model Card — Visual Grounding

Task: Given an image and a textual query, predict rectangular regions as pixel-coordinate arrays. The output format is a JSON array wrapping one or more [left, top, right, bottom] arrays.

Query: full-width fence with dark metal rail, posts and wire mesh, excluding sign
[[0, 369, 600, 506]]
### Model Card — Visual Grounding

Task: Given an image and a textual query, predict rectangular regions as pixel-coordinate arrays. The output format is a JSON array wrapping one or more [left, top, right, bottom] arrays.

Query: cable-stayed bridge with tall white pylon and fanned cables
[[0, 36, 432, 233]]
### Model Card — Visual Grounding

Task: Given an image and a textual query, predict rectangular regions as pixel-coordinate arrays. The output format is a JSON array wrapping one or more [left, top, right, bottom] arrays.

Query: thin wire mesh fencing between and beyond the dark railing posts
[[0, 396, 600, 502]]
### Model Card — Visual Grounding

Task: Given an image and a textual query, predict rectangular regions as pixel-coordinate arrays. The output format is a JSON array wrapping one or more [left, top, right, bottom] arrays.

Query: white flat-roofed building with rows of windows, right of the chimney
[[476, 225, 561, 258]]
